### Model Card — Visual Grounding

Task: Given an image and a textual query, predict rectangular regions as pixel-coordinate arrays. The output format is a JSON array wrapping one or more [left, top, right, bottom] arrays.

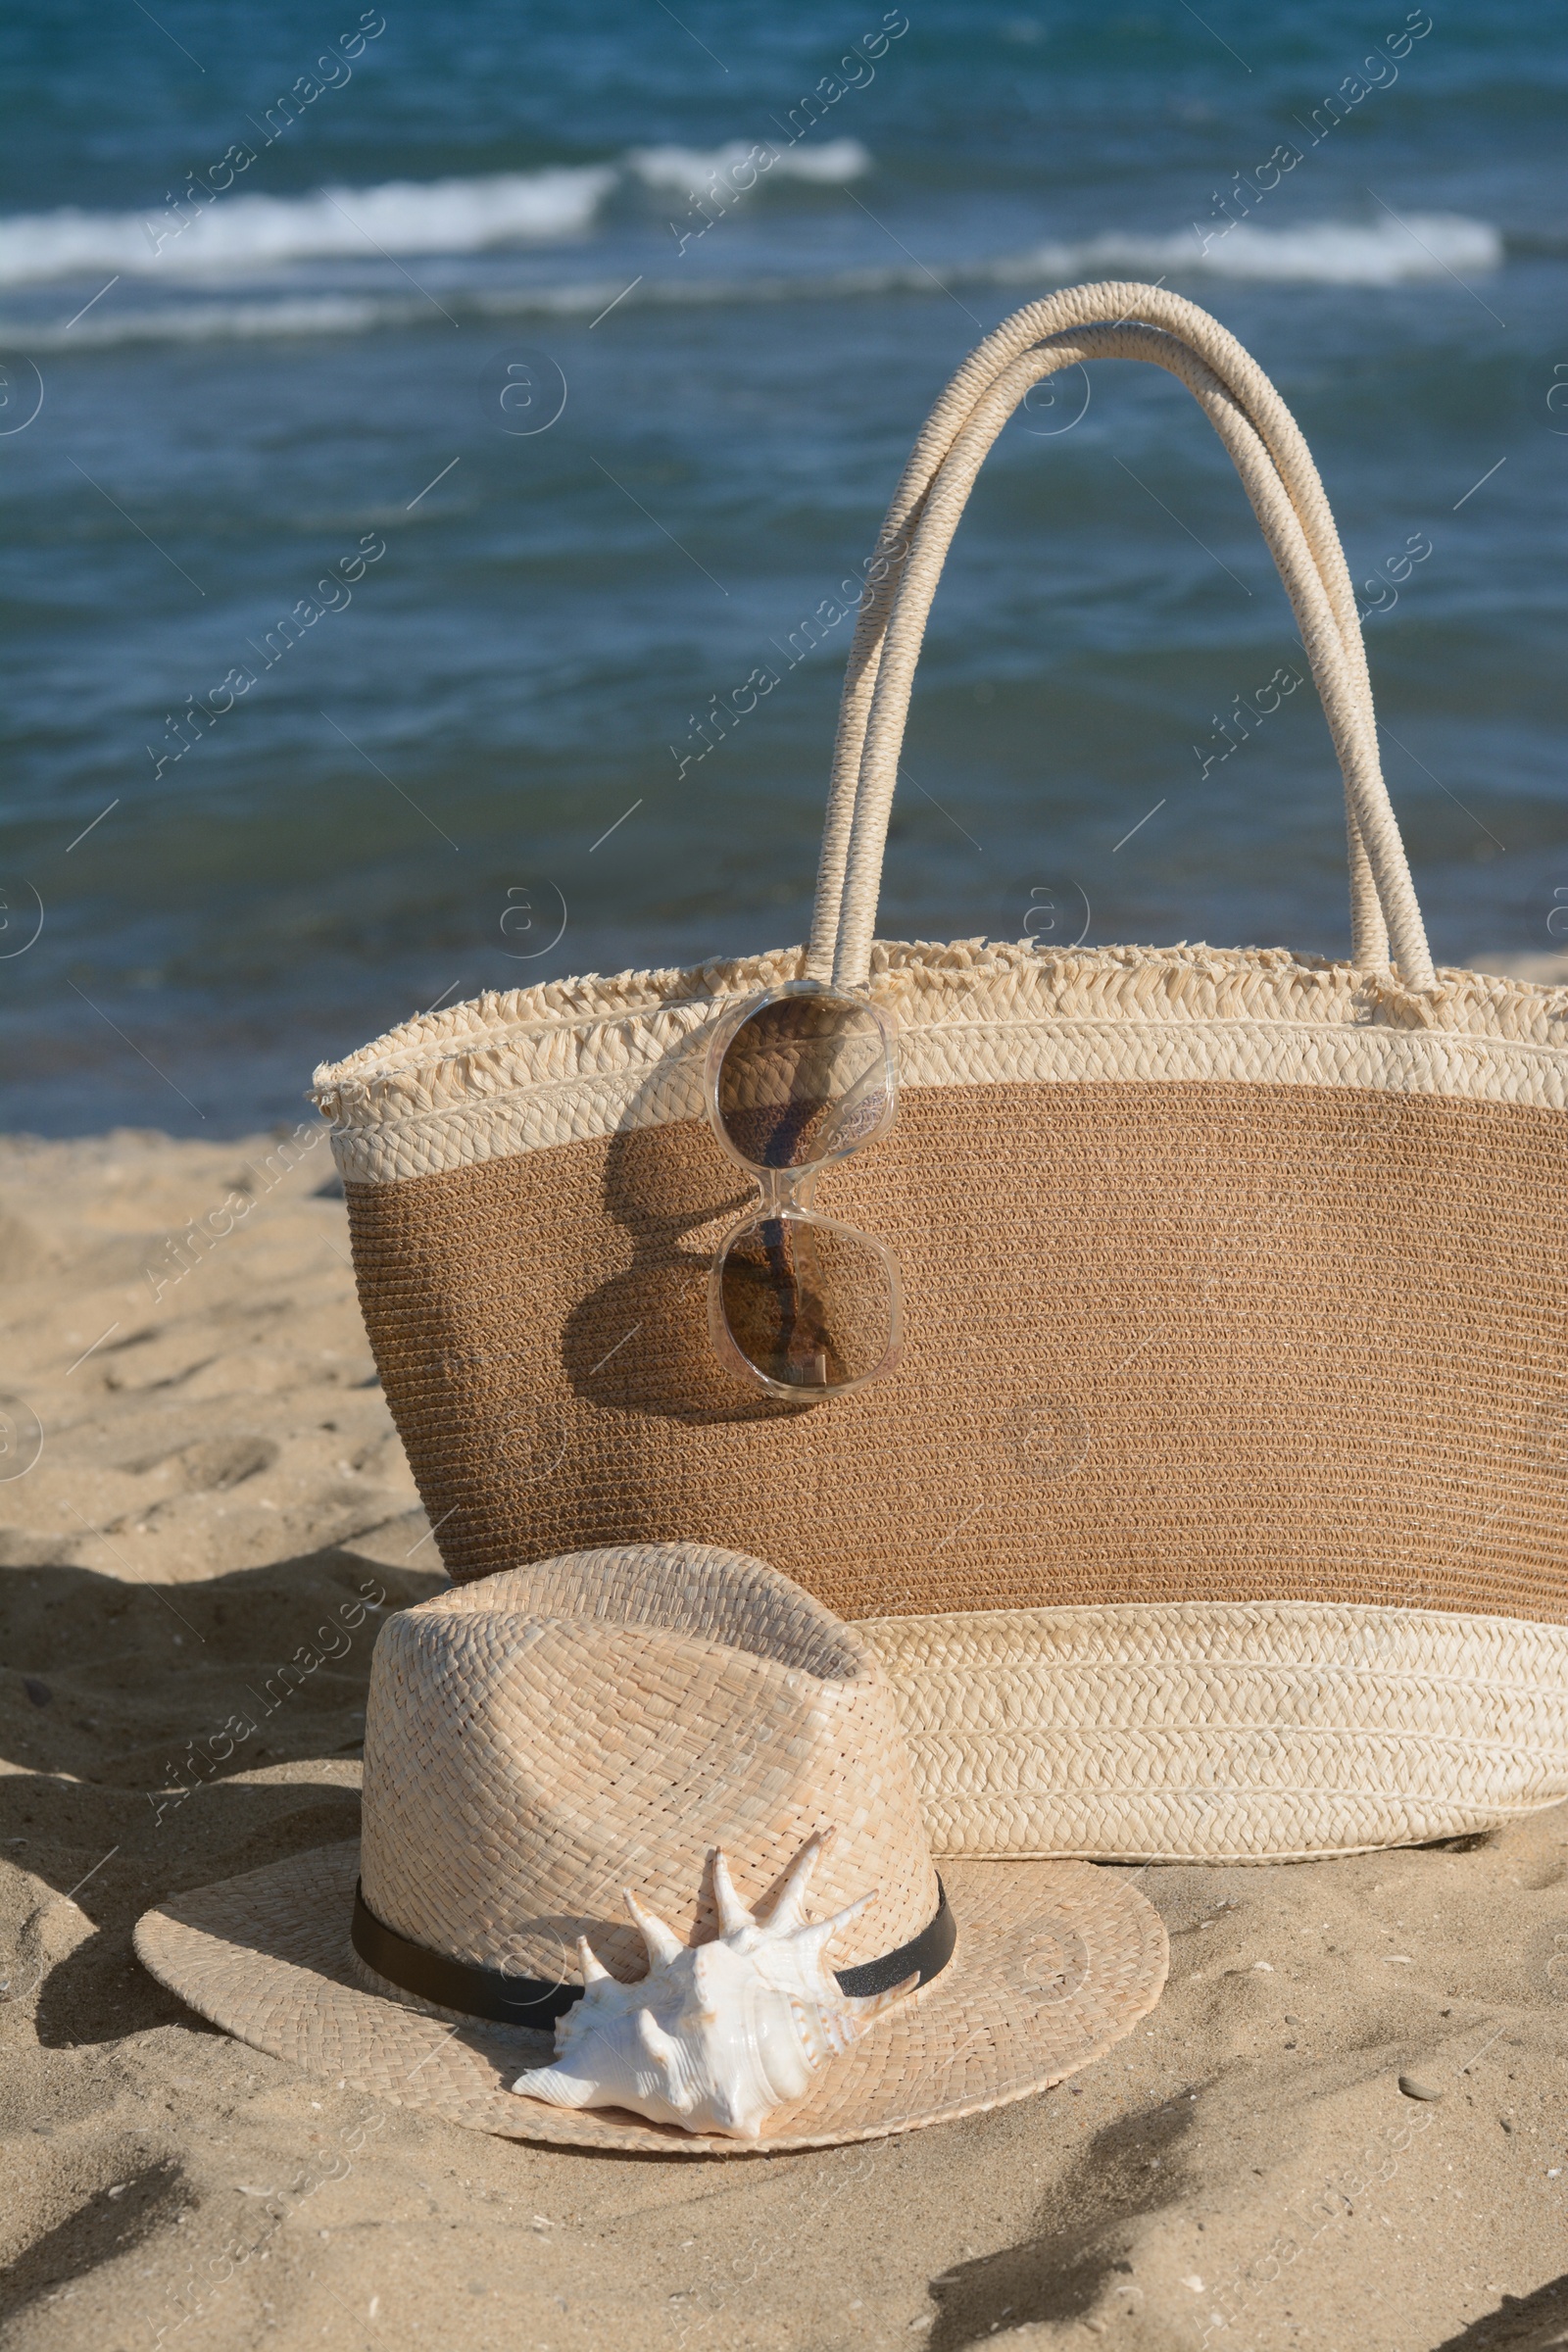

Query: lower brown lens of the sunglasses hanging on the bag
[[712, 1213, 898, 1395]]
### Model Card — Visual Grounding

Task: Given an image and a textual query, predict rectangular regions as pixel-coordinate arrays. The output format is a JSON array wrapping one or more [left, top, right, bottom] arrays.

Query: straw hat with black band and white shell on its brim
[[136, 1543, 1166, 2154]]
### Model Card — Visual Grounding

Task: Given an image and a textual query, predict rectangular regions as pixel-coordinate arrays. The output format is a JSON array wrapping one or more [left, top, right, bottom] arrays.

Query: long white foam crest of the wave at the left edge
[[0, 165, 620, 284]]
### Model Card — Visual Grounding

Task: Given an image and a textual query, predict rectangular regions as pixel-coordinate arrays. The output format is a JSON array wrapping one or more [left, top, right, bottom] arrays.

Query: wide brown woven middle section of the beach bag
[[324, 1080, 1568, 1623]]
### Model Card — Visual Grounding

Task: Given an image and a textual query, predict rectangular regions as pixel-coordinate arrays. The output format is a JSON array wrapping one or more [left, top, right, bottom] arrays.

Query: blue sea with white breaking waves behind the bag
[[0, 0, 1568, 1136]]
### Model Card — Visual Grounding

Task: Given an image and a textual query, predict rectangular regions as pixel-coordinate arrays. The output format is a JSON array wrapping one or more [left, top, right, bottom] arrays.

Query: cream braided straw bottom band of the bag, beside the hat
[[858, 1601, 1568, 1868]]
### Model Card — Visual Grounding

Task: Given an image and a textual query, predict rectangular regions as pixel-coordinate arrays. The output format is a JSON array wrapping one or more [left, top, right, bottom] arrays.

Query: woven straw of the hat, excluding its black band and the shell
[[136, 1545, 1166, 2154]]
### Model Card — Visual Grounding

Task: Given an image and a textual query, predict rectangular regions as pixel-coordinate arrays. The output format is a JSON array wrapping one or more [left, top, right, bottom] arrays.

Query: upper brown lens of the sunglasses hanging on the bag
[[714, 995, 894, 1169]]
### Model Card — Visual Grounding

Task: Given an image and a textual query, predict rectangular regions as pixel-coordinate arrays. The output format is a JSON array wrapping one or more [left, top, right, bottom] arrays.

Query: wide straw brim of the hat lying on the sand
[[136, 1839, 1168, 2157]]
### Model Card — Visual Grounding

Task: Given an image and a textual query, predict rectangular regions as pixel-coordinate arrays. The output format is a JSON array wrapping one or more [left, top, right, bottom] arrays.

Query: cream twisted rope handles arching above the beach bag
[[807, 284, 1432, 988]]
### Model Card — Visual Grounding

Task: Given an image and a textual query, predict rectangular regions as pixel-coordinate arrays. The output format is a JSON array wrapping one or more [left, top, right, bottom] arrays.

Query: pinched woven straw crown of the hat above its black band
[[360, 1543, 938, 1985]]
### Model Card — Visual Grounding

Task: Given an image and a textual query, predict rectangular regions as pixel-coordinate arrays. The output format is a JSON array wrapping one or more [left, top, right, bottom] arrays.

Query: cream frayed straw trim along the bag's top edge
[[313, 941, 1568, 1183]]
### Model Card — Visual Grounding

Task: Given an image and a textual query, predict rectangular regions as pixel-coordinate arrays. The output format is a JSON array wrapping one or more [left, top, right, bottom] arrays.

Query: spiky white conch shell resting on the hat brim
[[513, 1833, 914, 2140]]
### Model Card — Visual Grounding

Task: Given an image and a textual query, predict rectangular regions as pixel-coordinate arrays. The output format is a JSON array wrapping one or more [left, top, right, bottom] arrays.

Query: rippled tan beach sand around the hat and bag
[[0, 1127, 1568, 2352]]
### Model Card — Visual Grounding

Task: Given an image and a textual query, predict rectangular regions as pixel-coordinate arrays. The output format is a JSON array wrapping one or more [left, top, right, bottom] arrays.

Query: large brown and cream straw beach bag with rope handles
[[318, 284, 1568, 1858]]
